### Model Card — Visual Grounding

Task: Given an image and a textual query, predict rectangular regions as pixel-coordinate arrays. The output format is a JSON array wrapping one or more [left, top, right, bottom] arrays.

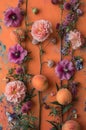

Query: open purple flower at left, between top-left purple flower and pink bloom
[[8, 44, 27, 64]]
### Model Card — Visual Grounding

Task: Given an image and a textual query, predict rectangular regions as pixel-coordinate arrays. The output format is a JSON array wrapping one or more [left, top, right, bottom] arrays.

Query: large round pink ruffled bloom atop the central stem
[[31, 20, 52, 44]]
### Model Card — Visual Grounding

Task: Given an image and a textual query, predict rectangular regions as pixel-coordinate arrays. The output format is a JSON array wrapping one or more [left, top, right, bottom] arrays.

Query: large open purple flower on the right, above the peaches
[[55, 60, 75, 80]]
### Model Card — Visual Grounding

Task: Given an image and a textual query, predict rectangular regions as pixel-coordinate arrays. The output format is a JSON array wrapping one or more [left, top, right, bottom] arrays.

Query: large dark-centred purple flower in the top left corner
[[4, 7, 23, 27]]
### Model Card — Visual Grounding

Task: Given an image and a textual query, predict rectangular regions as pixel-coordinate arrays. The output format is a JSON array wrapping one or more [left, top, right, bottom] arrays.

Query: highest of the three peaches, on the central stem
[[32, 75, 49, 91]]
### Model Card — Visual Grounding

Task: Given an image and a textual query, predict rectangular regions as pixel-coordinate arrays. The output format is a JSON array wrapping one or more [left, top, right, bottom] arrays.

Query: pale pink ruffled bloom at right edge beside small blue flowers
[[68, 30, 83, 50]]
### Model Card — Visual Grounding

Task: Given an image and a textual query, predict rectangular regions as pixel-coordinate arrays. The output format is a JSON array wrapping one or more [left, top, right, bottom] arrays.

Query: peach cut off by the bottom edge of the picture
[[62, 120, 81, 130]]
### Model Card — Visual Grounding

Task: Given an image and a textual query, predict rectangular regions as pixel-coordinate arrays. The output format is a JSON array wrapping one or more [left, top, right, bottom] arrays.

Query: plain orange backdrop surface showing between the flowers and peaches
[[0, 0, 86, 130]]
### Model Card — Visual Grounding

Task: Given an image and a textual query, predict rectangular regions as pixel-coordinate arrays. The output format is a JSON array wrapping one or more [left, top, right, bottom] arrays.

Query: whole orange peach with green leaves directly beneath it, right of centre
[[56, 88, 72, 105]]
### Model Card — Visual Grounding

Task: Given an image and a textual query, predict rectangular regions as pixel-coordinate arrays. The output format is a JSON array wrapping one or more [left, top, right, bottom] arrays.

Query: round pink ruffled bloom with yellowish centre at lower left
[[5, 81, 26, 104]]
